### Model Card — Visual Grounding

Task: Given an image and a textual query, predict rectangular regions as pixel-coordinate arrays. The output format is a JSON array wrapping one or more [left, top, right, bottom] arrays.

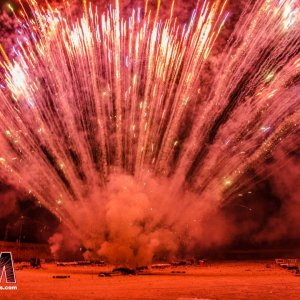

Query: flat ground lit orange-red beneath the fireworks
[[0, 262, 300, 300]]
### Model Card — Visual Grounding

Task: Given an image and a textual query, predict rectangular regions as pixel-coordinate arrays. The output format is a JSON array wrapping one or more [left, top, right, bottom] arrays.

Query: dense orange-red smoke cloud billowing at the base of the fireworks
[[50, 174, 231, 265]]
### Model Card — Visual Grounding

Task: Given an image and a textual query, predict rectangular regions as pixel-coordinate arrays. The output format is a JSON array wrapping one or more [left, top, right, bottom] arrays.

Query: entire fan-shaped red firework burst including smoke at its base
[[0, 0, 300, 264]]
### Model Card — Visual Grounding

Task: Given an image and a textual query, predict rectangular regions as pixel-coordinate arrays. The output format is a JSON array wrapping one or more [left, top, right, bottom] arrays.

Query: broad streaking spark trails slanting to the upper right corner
[[174, 1, 300, 197]]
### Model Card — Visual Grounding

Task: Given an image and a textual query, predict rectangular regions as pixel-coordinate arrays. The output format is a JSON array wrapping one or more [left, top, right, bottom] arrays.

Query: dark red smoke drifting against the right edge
[[257, 132, 300, 242]]
